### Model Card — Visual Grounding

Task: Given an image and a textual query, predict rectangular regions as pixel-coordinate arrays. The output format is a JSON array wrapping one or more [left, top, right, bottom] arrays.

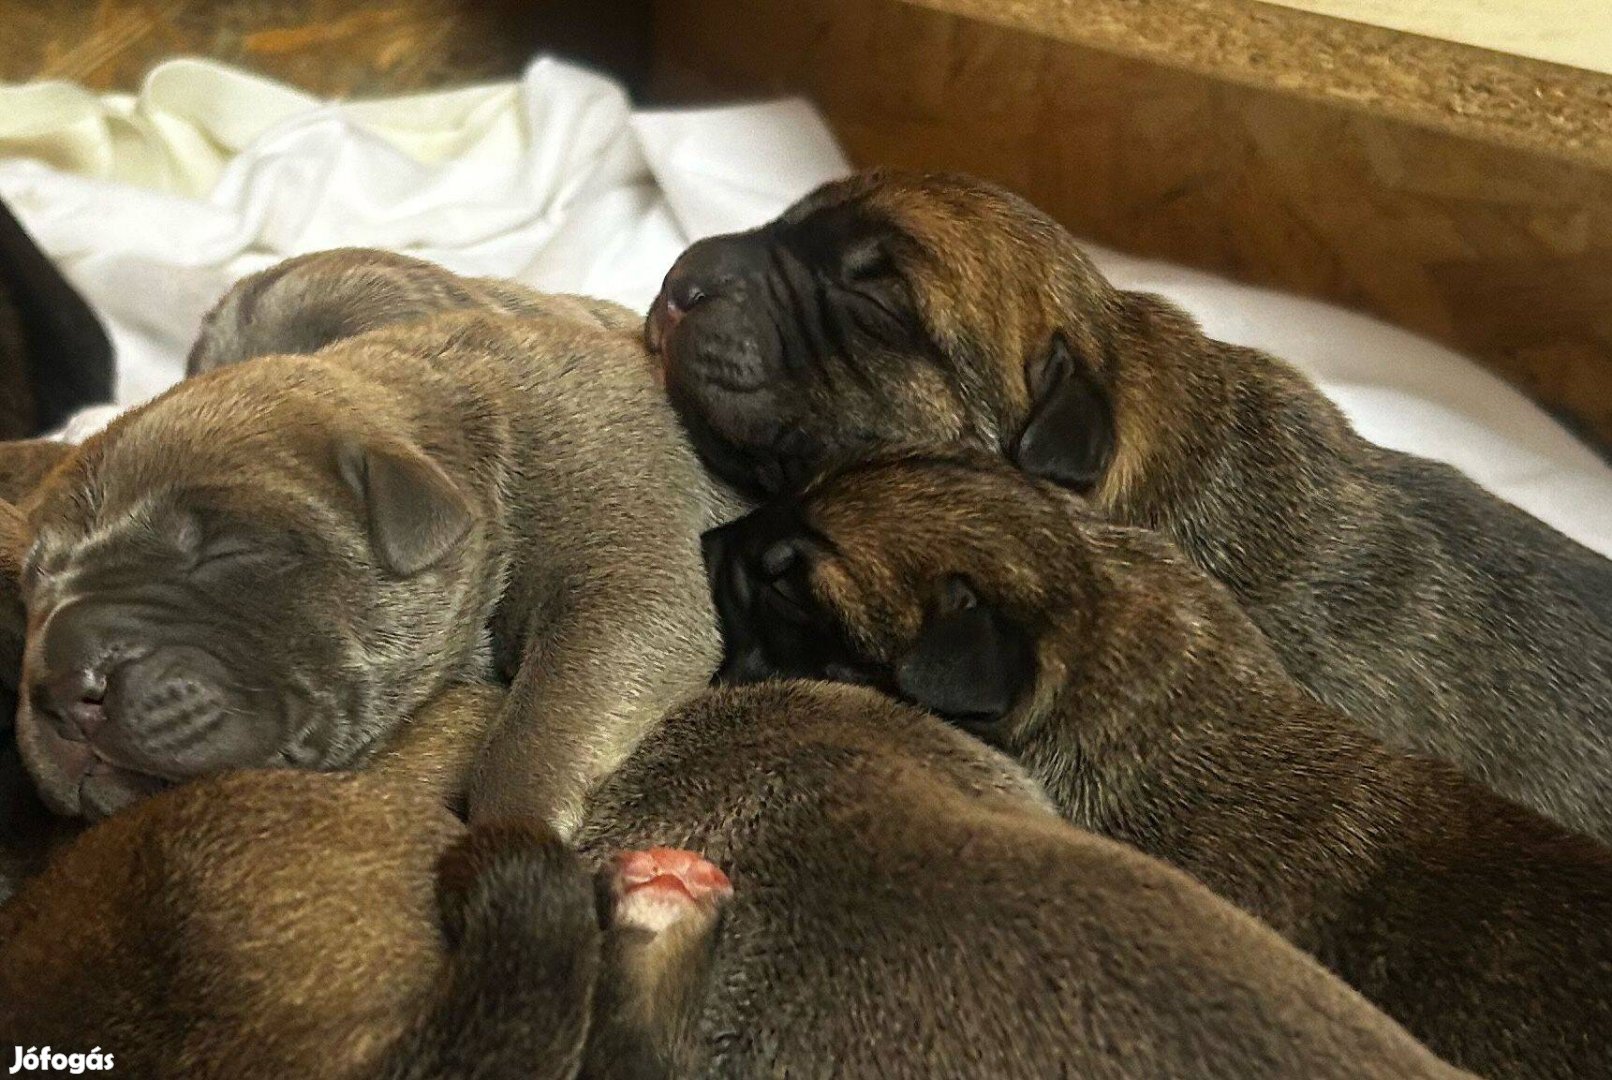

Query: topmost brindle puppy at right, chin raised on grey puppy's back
[[646, 172, 1612, 840]]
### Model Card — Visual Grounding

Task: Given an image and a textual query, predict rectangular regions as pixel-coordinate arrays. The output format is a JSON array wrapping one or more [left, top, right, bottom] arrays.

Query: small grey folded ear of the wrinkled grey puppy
[[335, 440, 474, 577]]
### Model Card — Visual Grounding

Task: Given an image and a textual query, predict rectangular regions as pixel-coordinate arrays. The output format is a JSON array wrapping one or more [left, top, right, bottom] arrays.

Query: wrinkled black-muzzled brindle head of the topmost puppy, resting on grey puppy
[[645, 172, 1120, 496]]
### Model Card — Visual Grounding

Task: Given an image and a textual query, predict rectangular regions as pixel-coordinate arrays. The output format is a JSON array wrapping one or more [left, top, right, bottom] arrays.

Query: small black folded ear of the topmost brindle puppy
[[1012, 334, 1114, 495]]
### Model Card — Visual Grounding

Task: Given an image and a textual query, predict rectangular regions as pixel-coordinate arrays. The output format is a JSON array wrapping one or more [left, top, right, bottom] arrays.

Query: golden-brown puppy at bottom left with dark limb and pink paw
[[0, 688, 727, 1080]]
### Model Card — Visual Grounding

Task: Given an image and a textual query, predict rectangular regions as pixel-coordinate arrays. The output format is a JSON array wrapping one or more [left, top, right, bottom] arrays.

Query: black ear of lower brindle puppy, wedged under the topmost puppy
[[896, 579, 1035, 725]]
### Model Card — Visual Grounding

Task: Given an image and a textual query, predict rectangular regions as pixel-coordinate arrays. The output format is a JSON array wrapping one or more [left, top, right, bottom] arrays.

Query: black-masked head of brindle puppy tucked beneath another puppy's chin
[[704, 455, 1088, 741]]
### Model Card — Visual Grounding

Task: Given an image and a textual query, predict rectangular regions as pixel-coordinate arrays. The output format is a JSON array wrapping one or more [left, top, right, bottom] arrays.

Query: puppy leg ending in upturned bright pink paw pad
[[584, 848, 733, 1080]]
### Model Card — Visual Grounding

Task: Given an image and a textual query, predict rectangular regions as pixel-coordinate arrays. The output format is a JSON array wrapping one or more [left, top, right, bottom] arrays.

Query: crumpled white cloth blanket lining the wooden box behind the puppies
[[0, 58, 1612, 556]]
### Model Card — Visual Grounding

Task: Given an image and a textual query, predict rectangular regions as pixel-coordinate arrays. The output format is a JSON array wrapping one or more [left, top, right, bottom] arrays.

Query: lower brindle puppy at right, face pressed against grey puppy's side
[[706, 451, 1612, 1077]]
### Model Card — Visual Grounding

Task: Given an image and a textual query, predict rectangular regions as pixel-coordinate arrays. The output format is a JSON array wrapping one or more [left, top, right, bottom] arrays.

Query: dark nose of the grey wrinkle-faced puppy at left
[[29, 604, 127, 740]]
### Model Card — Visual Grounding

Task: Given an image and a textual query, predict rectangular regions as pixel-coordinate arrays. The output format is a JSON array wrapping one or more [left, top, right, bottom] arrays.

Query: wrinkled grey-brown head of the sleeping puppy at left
[[18, 358, 488, 817]]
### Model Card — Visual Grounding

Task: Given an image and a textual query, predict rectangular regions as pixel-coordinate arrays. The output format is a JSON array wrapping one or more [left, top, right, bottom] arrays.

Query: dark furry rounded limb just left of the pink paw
[[379, 822, 601, 1080]]
